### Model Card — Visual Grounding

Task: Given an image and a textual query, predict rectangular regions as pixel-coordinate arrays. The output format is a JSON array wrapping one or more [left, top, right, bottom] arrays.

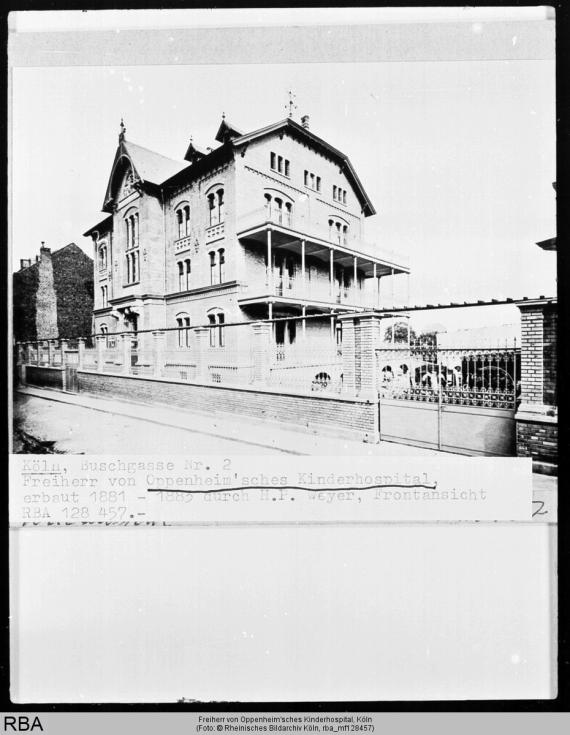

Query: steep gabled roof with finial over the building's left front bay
[[102, 138, 189, 212]]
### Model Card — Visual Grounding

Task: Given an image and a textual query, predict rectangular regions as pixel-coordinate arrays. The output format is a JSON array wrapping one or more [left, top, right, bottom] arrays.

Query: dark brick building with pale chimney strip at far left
[[13, 243, 93, 341]]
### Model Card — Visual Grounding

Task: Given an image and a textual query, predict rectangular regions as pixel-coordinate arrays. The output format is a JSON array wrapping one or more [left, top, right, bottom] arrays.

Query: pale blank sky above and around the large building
[[11, 33, 556, 326]]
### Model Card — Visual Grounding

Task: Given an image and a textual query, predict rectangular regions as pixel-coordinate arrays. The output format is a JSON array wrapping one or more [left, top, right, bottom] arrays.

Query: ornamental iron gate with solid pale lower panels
[[376, 345, 520, 456]]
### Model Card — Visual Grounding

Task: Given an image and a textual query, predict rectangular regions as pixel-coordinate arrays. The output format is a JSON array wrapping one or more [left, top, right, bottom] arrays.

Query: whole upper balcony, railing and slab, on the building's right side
[[237, 207, 410, 278]]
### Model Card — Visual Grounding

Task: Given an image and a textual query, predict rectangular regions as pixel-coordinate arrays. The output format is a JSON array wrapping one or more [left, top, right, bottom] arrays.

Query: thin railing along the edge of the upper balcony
[[237, 207, 409, 269]]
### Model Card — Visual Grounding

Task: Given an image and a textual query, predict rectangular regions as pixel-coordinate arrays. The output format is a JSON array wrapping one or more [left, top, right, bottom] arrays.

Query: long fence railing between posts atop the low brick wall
[[16, 322, 342, 400]]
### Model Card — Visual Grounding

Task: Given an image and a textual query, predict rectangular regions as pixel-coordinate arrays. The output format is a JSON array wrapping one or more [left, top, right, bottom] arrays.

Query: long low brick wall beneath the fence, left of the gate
[[75, 371, 378, 441]]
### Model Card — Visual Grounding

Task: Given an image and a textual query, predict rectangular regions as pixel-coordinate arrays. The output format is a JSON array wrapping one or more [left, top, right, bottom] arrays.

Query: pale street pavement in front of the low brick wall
[[14, 387, 557, 492]]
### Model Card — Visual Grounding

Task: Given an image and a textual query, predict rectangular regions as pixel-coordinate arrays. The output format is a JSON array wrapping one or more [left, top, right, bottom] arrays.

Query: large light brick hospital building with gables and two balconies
[[85, 116, 409, 359]]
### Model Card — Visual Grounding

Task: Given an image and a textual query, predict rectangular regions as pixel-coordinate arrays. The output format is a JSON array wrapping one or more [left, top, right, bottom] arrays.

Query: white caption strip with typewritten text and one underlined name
[[6, 455, 536, 526]]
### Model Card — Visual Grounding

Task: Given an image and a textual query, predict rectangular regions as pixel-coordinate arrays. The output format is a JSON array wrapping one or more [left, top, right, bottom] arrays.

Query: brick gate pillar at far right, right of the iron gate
[[515, 299, 558, 474]]
